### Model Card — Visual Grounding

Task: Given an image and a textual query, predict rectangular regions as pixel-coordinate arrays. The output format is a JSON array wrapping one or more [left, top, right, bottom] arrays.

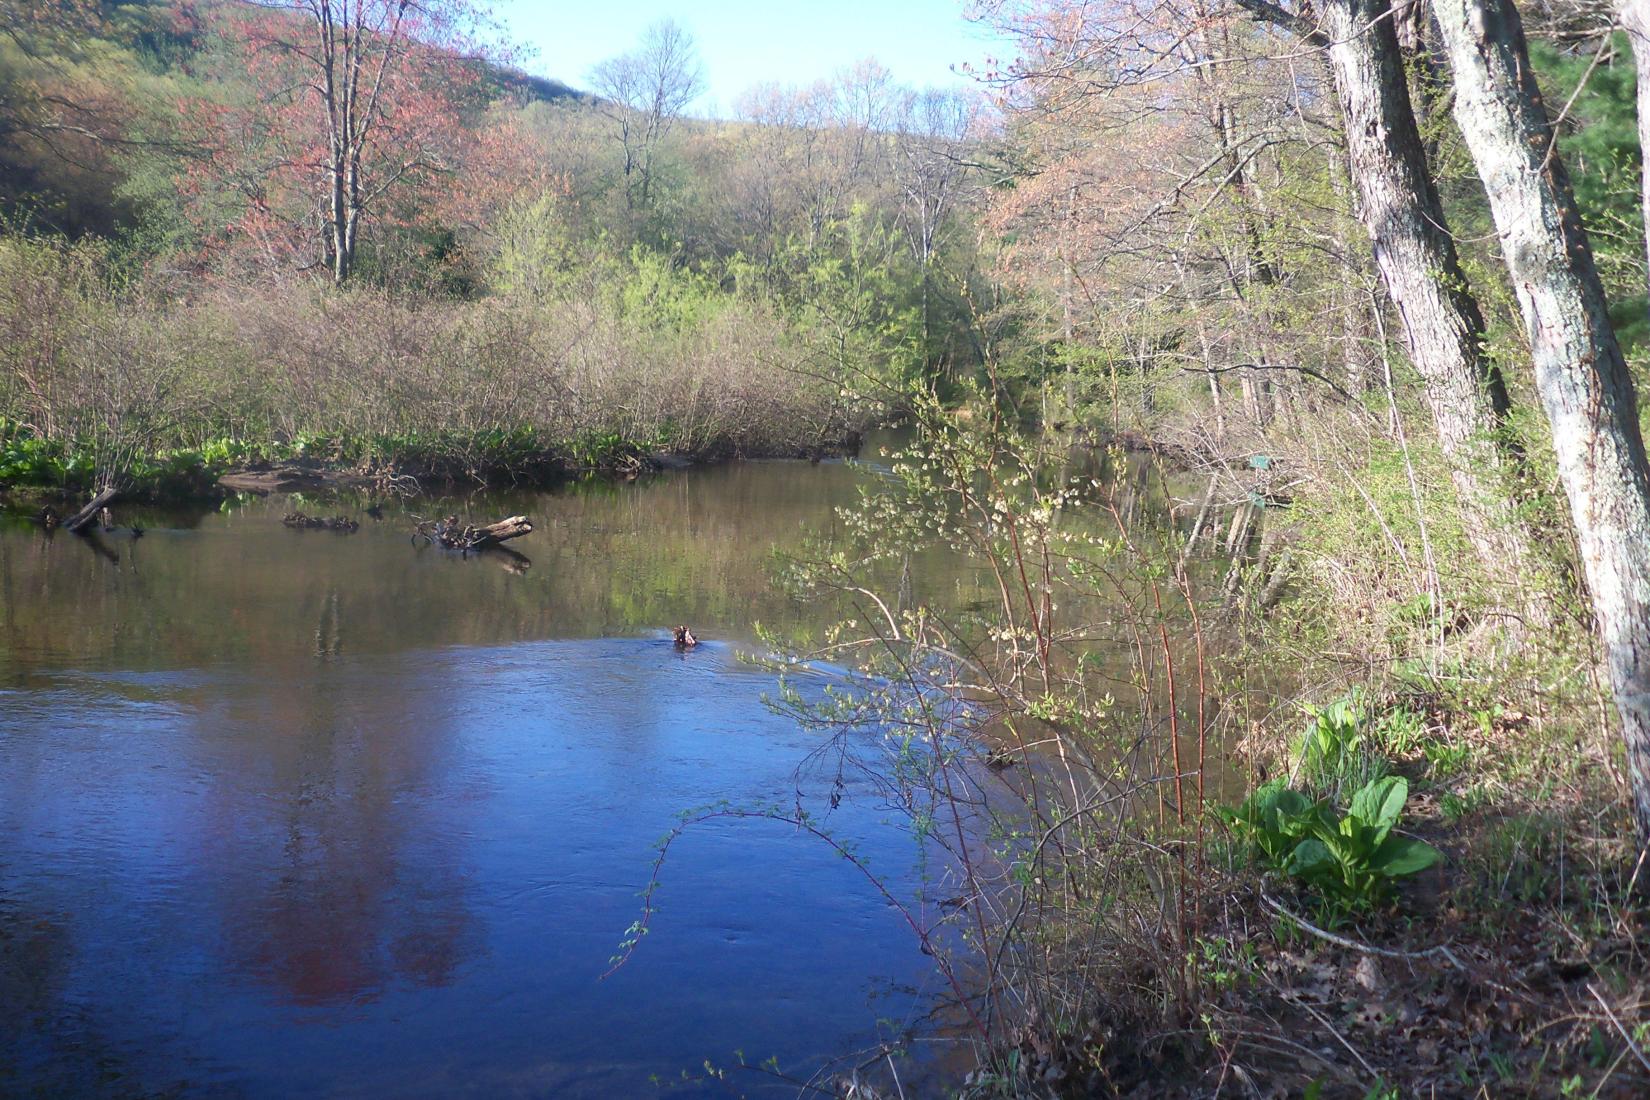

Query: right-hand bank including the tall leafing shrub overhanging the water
[[752, 409, 1650, 1098]]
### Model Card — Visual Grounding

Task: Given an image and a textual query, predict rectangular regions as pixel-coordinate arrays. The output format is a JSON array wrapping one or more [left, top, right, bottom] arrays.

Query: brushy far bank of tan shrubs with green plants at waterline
[[0, 237, 875, 495]]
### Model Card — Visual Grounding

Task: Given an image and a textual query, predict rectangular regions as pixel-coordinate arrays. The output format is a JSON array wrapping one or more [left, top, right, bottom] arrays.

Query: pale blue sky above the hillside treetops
[[493, 0, 1003, 114]]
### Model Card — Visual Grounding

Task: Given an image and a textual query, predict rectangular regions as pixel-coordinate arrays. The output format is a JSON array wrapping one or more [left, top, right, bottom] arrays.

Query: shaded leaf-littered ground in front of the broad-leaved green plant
[[990, 705, 1650, 1100]]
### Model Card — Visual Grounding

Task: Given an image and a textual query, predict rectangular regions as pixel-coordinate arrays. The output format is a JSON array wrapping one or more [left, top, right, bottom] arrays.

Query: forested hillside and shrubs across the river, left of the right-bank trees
[[0, 3, 990, 473]]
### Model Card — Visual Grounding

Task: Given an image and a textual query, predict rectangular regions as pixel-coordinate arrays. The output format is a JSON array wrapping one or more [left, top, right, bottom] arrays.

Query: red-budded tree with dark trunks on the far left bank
[[191, 0, 479, 285]]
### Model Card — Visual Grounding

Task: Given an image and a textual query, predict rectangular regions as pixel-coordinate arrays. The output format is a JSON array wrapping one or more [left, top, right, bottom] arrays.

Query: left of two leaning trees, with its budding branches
[[993, 0, 1521, 448]]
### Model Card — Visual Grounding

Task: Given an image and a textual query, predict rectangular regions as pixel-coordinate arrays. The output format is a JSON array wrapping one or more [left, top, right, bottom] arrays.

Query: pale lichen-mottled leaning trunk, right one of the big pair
[[1432, 0, 1650, 841]]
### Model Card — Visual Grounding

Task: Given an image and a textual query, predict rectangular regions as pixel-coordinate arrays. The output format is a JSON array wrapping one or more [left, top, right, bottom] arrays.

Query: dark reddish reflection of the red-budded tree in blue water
[[201, 653, 475, 1004]]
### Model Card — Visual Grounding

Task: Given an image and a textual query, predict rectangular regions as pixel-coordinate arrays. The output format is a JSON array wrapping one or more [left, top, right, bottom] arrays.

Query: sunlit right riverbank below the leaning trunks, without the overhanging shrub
[[1003, 385, 1650, 1100]]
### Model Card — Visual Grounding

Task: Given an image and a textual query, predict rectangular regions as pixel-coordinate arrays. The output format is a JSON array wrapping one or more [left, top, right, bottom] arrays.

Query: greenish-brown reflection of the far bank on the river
[[0, 450, 1188, 668]]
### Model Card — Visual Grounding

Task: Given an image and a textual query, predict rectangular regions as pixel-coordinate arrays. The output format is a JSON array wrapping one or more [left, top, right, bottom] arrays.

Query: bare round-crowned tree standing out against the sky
[[591, 20, 705, 209]]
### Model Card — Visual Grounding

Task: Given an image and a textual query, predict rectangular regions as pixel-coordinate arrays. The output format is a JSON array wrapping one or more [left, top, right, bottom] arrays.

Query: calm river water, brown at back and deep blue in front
[[0, 451, 982, 1097]]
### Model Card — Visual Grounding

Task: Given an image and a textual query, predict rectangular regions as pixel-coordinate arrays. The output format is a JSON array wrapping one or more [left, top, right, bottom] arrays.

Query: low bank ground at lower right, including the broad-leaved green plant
[[965, 693, 1650, 1100]]
